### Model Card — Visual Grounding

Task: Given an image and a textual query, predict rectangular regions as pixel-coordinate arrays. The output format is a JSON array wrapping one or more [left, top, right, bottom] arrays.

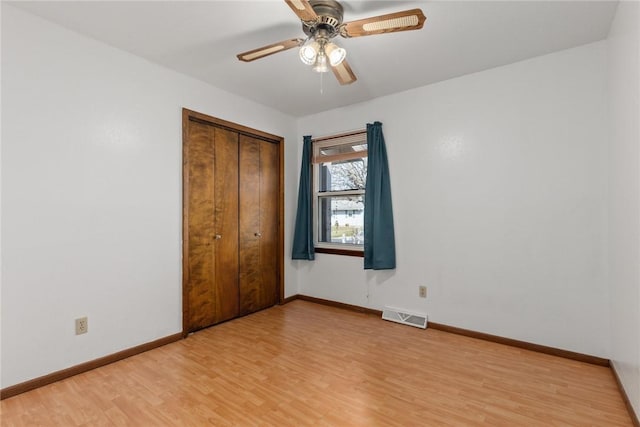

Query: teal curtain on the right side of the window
[[364, 122, 396, 270]]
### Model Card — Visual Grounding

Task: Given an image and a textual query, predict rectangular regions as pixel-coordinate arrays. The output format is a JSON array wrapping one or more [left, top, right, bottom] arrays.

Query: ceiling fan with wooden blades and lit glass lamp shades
[[238, 0, 427, 85]]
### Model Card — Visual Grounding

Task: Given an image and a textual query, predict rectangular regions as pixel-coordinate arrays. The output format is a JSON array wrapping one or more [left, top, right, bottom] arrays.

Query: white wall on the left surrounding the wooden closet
[[0, 2, 298, 387]]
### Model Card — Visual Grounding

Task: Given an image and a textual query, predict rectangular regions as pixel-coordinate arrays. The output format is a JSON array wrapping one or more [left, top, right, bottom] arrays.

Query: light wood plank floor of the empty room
[[1, 301, 632, 427]]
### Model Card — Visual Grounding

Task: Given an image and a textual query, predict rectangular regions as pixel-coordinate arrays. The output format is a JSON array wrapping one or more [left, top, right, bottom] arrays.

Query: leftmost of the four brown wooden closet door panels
[[187, 123, 215, 330]]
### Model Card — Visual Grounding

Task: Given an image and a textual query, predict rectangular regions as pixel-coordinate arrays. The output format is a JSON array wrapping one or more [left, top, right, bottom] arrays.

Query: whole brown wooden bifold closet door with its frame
[[183, 109, 283, 334]]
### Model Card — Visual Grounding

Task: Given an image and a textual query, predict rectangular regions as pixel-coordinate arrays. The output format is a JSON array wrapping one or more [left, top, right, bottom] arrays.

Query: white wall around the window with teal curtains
[[298, 42, 609, 357]]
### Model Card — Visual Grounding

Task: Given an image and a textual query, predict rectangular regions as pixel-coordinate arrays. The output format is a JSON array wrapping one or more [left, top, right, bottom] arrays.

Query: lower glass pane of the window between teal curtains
[[318, 194, 364, 245]]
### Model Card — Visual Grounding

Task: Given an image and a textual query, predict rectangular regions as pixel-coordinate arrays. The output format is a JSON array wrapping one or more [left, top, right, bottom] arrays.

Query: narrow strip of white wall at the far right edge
[[608, 2, 640, 416]]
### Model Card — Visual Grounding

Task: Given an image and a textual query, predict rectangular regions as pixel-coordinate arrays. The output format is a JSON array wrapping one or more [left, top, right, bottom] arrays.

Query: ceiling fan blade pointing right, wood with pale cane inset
[[340, 9, 427, 37]]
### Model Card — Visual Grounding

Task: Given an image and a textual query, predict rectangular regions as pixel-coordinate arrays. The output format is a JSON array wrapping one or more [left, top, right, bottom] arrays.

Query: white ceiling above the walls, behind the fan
[[8, 0, 617, 116]]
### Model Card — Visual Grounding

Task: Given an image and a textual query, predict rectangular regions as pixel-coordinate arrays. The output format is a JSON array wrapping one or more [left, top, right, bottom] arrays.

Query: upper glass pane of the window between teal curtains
[[319, 157, 367, 191]]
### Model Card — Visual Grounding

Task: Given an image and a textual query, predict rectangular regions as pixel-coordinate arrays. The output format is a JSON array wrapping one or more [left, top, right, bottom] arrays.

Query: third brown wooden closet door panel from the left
[[239, 135, 262, 314]]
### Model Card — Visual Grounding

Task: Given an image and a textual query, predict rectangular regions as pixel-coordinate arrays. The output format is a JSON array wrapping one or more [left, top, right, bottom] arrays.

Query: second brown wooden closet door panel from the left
[[211, 127, 239, 323]]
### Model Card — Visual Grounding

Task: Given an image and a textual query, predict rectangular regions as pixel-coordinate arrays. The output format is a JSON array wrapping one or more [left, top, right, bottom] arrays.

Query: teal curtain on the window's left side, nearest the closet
[[291, 136, 315, 260]]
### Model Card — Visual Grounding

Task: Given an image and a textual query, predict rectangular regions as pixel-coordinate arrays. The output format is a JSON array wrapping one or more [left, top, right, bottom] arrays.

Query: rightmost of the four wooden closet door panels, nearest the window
[[259, 141, 280, 308]]
